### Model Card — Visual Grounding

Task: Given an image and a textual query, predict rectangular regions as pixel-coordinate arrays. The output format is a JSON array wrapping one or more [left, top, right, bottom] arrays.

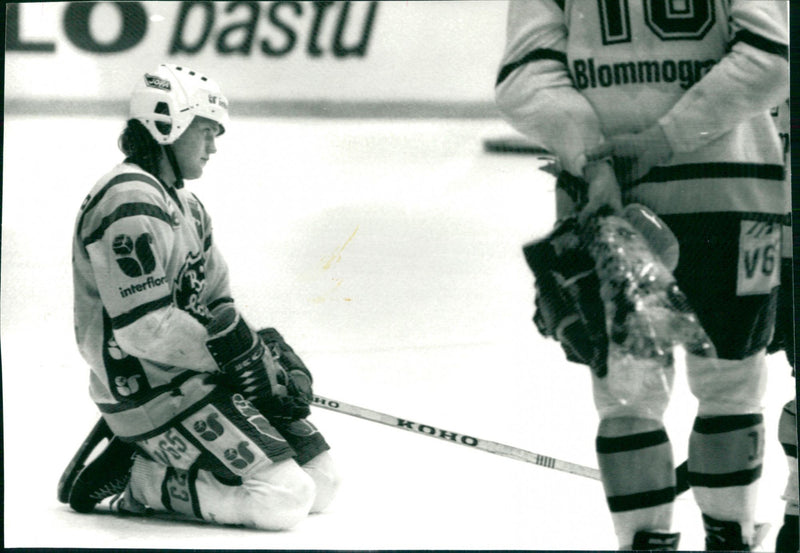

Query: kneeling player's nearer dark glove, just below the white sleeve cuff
[[206, 306, 289, 416]]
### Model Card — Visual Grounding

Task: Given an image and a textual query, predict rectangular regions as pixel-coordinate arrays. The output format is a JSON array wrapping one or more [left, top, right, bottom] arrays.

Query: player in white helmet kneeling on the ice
[[59, 65, 338, 530]]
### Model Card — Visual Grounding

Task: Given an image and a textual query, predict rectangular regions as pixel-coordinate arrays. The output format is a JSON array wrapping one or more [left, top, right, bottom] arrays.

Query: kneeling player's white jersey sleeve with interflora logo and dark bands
[[78, 176, 216, 370]]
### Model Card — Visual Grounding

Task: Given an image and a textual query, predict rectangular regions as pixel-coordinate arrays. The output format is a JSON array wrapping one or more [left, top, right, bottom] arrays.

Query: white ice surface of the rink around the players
[[0, 115, 794, 551]]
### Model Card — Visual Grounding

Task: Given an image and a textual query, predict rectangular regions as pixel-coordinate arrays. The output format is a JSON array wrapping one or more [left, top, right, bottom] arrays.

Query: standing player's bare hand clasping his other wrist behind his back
[[609, 123, 672, 184]]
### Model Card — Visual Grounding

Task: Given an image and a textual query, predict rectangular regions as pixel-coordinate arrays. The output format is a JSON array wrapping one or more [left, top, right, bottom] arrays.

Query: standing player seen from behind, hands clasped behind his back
[[496, 0, 788, 551]]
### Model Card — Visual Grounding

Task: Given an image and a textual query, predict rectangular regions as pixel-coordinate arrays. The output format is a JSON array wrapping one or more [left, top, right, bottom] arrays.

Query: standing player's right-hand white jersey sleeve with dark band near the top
[[659, 0, 789, 152]]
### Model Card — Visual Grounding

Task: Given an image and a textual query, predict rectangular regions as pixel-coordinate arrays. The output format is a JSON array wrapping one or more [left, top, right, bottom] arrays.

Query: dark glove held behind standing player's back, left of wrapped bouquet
[[523, 217, 608, 377]]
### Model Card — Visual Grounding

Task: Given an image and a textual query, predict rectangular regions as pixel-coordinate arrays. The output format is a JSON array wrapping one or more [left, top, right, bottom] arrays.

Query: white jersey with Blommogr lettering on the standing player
[[496, 0, 788, 218]]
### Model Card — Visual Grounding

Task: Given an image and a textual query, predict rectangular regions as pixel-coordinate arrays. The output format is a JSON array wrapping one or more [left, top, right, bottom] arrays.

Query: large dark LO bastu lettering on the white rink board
[[6, 1, 379, 58]]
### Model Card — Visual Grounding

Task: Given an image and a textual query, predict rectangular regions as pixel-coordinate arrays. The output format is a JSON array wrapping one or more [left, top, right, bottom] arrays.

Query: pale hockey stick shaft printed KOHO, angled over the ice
[[314, 396, 600, 480]]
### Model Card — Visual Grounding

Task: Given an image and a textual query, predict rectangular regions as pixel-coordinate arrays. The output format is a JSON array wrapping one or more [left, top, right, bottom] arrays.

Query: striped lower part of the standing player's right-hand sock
[[689, 414, 764, 543]]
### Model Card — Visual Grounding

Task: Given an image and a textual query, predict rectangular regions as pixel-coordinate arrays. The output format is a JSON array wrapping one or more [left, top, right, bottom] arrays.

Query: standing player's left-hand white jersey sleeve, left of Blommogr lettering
[[495, 0, 604, 175]]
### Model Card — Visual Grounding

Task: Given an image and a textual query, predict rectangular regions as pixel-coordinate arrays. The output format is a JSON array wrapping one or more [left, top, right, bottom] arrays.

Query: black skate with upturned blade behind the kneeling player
[[58, 423, 136, 513]]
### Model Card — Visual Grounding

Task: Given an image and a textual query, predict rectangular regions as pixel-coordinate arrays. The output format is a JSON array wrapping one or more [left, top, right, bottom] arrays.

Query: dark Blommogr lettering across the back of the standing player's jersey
[[571, 58, 716, 90]]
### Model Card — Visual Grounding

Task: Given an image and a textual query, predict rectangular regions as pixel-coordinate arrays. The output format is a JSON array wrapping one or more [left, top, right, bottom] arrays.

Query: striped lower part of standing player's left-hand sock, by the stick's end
[[596, 427, 675, 546]]
